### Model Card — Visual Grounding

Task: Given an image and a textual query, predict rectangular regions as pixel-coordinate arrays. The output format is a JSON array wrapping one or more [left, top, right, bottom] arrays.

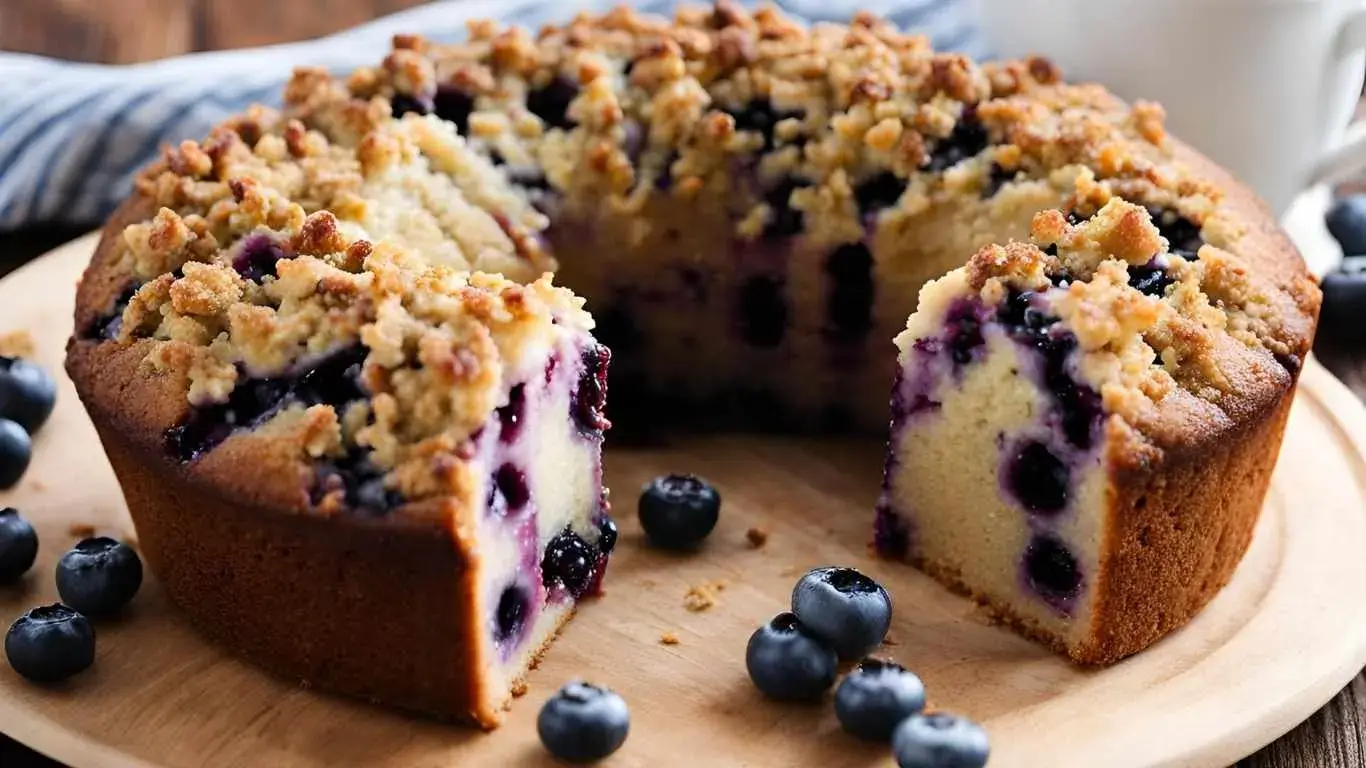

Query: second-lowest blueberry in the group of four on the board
[[835, 659, 925, 742]]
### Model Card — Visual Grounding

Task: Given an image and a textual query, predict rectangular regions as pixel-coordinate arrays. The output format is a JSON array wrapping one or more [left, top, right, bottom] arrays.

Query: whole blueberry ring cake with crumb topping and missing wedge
[[68, 1, 1318, 726]]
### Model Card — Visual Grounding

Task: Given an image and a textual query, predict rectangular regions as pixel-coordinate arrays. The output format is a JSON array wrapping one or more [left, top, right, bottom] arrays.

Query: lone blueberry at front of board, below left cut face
[[535, 681, 631, 763]]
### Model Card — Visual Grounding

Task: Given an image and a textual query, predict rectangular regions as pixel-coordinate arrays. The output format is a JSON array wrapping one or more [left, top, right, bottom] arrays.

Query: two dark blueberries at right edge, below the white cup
[[1318, 194, 1366, 344]]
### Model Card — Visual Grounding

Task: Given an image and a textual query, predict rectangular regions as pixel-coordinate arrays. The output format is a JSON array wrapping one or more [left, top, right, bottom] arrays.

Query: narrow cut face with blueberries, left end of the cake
[[474, 338, 615, 709]]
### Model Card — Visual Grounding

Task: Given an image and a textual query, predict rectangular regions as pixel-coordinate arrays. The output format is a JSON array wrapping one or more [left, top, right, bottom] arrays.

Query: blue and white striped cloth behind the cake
[[0, 0, 985, 232]]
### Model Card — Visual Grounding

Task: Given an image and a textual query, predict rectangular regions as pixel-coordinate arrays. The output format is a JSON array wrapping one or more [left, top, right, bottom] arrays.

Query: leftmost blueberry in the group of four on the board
[[744, 614, 839, 701]]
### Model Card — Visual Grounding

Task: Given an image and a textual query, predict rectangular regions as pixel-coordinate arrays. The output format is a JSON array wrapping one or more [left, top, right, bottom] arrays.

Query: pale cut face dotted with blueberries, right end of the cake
[[877, 273, 1106, 648]]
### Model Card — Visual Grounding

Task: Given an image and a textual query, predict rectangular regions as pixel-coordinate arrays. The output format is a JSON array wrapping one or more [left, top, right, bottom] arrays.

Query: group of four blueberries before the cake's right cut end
[[744, 567, 989, 768]]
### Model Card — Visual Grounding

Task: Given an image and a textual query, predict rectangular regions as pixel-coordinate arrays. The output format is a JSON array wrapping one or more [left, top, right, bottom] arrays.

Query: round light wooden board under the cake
[[0, 238, 1366, 768]]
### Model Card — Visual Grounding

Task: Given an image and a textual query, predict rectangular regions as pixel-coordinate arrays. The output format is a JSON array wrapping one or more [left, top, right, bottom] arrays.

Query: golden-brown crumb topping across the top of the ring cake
[[69, 0, 1318, 513]]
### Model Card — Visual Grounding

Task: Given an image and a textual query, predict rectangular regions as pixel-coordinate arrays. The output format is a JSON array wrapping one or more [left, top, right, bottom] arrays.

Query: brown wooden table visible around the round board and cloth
[[0, 0, 1366, 768]]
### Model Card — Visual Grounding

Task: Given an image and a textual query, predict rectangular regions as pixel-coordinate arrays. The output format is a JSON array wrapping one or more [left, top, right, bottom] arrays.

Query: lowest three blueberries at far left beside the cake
[[0, 508, 142, 683]]
